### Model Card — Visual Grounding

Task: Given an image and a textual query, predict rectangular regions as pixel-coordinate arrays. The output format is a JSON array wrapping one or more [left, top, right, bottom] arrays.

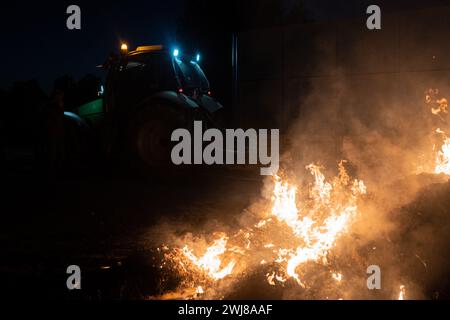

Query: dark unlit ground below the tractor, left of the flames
[[0, 149, 261, 299]]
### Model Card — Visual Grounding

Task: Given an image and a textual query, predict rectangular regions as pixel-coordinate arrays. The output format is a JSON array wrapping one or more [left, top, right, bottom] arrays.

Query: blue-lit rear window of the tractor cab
[[175, 59, 209, 92]]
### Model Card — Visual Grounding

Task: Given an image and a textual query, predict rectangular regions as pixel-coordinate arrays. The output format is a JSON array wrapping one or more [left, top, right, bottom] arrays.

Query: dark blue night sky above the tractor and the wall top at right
[[0, 0, 450, 91]]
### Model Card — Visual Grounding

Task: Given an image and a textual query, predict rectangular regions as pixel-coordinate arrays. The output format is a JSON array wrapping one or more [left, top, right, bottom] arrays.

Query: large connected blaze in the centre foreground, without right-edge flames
[[160, 161, 366, 298]]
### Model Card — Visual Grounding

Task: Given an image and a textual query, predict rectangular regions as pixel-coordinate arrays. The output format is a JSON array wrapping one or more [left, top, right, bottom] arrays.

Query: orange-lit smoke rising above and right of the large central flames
[[274, 53, 450, 299]]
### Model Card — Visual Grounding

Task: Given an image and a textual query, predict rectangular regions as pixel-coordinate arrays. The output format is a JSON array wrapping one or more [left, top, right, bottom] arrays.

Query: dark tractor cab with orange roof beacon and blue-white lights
[[106, 45, 220, 111]]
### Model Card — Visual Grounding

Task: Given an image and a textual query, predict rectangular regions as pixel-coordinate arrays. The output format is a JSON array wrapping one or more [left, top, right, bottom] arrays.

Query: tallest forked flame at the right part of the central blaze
[[272, 162, 366, 286]]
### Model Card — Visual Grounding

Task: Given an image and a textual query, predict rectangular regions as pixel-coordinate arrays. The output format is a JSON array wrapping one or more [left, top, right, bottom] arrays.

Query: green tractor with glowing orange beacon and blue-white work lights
[[64, 44, 223, 174]]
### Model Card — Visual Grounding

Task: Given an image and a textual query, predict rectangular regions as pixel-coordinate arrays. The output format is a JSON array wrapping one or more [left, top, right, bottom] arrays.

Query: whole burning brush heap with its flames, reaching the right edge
[[145, 91, 450, 299]]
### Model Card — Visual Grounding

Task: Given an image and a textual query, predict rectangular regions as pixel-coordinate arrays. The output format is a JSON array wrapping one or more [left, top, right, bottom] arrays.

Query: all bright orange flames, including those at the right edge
[[148, 90, 450, 300]]
